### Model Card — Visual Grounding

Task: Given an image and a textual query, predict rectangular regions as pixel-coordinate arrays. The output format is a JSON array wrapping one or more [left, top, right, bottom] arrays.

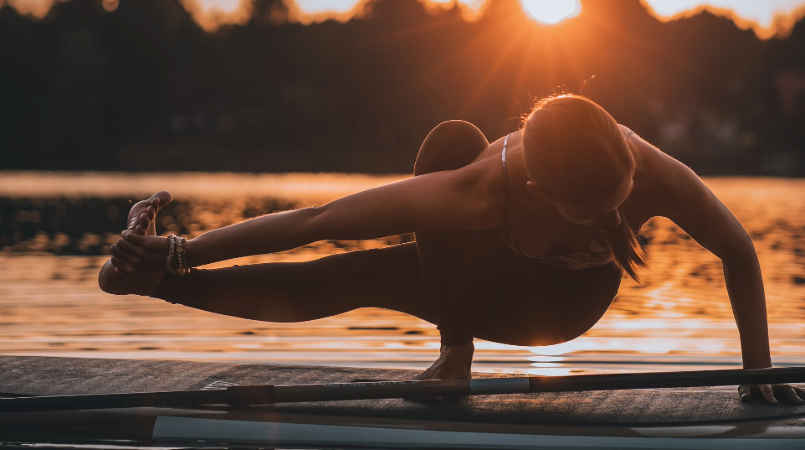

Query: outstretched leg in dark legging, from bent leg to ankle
[[153, 242, 435, 323]]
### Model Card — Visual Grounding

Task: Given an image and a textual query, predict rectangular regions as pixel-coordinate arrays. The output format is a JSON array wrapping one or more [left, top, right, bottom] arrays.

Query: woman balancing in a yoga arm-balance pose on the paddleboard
[[100, 94, 805, 404]]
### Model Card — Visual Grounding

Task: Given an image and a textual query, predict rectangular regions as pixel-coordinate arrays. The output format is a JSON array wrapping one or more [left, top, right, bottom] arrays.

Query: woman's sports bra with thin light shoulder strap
[[498, 133, 614, 270]]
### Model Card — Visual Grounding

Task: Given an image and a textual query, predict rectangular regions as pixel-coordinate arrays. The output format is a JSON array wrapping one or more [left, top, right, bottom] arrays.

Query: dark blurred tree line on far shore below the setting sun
[[0, 0, 805, 176]]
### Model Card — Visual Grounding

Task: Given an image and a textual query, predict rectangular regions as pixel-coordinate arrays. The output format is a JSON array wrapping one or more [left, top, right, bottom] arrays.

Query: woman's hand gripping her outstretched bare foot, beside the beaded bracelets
[[109, 230, 169, 276]]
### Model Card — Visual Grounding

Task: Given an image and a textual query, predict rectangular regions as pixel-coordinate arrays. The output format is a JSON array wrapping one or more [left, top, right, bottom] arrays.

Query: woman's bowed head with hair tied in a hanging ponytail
[[521, 94, 645, 279]]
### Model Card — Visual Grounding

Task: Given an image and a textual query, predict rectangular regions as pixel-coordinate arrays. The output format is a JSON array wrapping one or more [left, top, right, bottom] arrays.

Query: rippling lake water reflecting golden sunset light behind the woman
[[0, 172, 805, 375]]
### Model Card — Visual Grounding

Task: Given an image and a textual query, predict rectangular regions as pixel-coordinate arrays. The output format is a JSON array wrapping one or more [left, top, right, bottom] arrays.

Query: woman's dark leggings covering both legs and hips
[[154, 120, 621, 345]]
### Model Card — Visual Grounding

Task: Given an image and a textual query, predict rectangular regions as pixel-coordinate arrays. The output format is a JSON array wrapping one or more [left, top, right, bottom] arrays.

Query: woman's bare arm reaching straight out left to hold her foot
[[113, 164, 502, 273]]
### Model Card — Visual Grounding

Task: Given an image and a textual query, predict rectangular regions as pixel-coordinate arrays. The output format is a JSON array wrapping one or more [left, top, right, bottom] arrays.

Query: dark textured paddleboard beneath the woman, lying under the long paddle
[[0, 356, 805, 449]]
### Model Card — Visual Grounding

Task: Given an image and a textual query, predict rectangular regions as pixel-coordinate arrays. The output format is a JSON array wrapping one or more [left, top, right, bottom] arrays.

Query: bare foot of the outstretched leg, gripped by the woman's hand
[[98, 191, 173, 296]]
